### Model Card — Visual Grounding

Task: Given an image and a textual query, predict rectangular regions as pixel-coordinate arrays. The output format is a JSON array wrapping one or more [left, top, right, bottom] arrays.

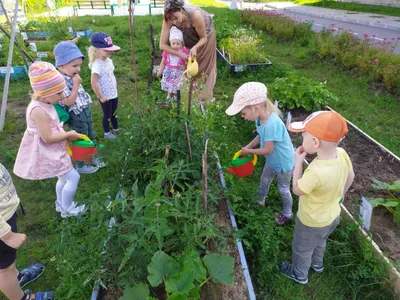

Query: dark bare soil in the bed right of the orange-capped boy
[[292, 110, 400, 269]]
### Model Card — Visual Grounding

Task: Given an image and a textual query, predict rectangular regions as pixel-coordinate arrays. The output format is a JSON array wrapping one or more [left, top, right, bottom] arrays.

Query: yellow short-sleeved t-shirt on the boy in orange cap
[[297, 147, 353, 227]]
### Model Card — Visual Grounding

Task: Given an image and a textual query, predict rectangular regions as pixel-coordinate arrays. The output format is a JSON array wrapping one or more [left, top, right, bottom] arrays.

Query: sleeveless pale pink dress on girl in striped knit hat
[[14, 100, 73, 180]]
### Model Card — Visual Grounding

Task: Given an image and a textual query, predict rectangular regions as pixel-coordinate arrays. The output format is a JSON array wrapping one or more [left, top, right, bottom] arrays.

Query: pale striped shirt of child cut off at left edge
[[0, 164, 19, 238]]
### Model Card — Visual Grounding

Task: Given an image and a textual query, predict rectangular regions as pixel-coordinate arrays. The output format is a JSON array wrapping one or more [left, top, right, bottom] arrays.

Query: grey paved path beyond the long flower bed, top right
[[218, 0, 400, 54]]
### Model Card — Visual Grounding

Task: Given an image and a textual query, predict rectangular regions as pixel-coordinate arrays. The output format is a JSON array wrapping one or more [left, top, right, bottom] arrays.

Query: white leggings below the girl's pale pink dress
[[56, 168, 80, 210]]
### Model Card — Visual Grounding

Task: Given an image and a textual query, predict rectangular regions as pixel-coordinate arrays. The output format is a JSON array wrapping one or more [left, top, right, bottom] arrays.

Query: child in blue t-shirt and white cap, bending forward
[[226, 82, 294, 225]]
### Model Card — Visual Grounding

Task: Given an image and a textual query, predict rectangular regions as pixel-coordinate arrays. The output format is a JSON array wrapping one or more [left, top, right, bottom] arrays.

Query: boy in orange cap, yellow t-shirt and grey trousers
[[279, 111, 354, 284]]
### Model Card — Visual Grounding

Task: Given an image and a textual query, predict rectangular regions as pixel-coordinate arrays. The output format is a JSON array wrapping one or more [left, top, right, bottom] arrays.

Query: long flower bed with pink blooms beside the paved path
[[242, 11, 400, 92]]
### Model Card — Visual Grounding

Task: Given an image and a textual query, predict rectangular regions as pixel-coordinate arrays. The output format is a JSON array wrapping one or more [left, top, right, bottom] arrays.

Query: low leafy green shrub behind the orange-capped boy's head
[[269, 75, 337, 111]]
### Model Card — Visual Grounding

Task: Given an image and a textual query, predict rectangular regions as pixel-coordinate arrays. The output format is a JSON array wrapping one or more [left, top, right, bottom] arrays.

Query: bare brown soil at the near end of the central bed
[[200, 200, 249, 300]]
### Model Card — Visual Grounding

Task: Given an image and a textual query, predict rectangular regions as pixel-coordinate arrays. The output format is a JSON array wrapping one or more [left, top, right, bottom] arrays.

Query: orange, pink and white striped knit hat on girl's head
[[29, 61, 66, 98]]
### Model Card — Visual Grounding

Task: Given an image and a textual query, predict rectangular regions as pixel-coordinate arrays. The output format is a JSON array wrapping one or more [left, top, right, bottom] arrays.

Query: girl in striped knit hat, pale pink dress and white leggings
[[14, 62, 86, 218]]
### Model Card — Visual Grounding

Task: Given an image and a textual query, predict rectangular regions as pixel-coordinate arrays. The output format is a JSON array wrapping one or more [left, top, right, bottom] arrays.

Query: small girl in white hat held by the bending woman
[[157, 26, 189, 101]]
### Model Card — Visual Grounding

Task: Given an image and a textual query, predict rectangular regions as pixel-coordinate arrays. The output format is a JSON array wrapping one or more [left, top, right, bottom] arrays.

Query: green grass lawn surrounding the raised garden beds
[[0, 2, 400, 300]]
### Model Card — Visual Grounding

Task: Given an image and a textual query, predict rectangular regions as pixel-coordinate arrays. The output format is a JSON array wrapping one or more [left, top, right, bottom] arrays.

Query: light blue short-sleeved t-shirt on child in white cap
[[256, 113, 294, 172]]
